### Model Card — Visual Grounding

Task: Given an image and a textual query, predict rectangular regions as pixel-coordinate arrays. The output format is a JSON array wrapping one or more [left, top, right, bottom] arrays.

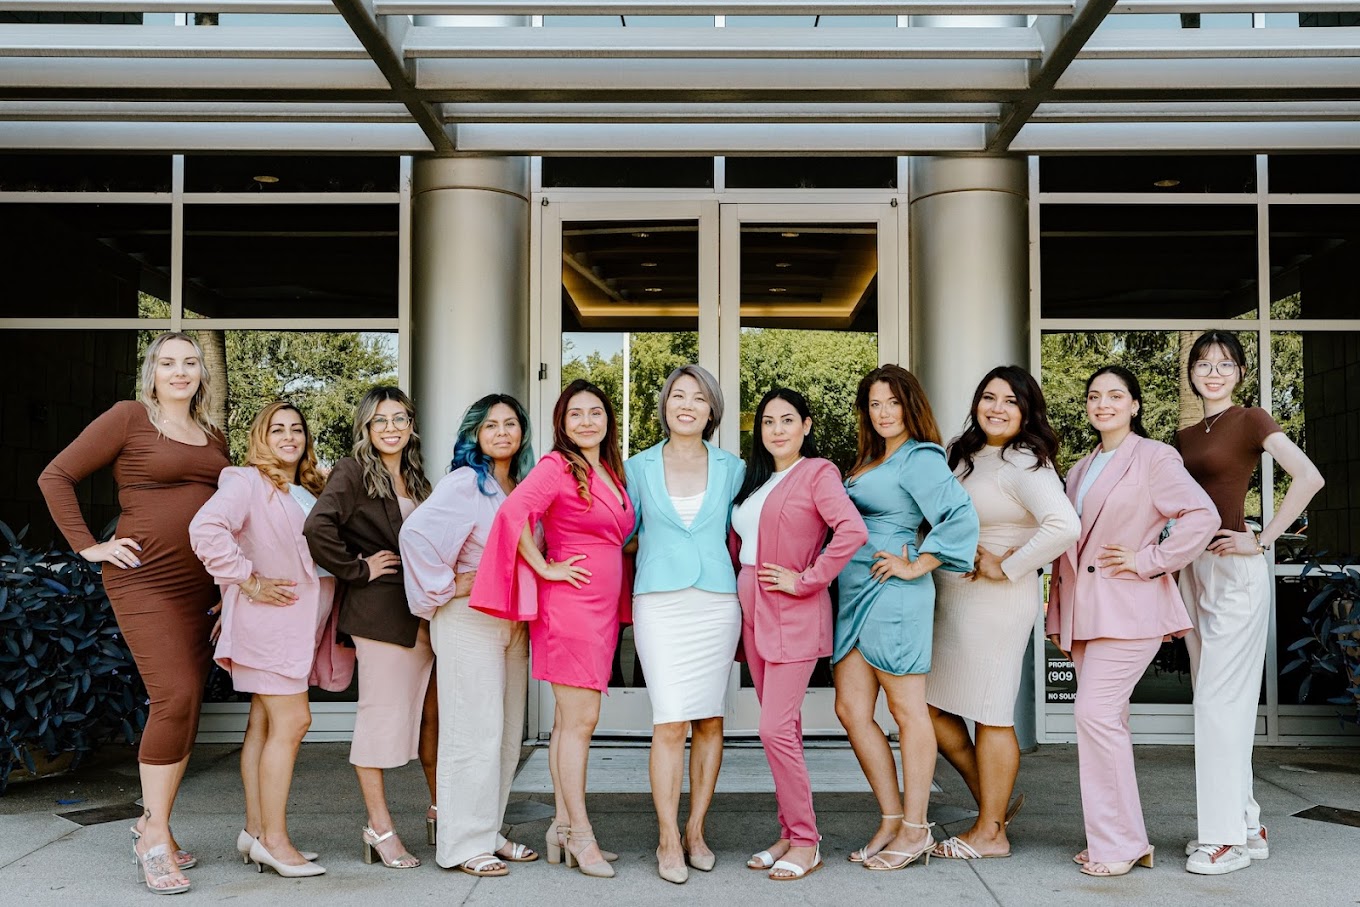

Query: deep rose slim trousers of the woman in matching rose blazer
[[737, 567, 821, 847]]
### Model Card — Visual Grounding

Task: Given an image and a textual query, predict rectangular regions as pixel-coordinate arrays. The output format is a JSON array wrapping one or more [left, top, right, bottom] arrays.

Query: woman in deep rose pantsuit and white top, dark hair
[[732, 388, 869, 881]]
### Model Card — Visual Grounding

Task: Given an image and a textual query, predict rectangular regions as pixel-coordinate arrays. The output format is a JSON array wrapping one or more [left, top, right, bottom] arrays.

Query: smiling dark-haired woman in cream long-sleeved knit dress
[[926, 366, 1081, 859]]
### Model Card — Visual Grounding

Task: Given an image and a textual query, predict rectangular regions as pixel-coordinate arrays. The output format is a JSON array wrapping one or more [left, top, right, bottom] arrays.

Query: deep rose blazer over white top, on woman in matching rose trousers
[[732, 457, 869, 664]]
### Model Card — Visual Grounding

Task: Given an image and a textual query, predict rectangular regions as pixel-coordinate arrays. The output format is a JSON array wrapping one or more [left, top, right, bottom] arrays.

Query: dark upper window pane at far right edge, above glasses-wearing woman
[[1270, 205, 1360, 318]]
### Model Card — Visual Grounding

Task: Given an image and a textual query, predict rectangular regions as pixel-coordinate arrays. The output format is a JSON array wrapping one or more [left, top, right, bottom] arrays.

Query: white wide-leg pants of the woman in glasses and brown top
[[1180, 551, 1270, 844]]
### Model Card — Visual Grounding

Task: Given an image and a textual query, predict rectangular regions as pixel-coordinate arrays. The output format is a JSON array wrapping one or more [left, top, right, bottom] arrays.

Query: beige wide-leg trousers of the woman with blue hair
[[430, 598, 529, 869]]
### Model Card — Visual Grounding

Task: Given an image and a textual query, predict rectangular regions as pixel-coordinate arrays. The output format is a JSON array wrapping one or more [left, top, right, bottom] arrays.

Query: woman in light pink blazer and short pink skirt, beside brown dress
[[189, 403, 354, 877]]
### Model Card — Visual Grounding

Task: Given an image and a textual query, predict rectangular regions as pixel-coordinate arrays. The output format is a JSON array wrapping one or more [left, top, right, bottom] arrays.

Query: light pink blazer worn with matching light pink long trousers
[[1044, 435, 1219, 650]]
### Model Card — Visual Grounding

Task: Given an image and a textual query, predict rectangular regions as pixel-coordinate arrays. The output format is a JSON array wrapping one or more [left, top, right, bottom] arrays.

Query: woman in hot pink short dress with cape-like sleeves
[[472, 379, 635, 878]]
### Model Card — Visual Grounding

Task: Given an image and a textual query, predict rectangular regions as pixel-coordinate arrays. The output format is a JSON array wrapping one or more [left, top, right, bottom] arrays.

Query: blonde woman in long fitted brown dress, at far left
[[38, 333, 231, 893]]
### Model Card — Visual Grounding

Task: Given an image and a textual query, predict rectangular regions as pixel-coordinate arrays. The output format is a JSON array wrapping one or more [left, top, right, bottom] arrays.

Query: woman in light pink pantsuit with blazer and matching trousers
[[1046, 366, 1219, 876]]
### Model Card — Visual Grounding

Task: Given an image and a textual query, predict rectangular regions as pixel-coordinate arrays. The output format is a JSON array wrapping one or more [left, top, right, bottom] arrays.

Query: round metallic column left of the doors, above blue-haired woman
[[411, 158, 527, 467]]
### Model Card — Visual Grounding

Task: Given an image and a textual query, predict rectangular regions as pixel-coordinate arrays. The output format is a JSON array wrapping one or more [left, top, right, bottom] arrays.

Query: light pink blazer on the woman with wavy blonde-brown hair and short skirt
[[189, 466, 354, 691]]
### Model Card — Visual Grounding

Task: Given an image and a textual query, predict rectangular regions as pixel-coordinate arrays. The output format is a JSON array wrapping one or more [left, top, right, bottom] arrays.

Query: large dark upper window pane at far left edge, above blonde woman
[[0, 204, 170, 318]]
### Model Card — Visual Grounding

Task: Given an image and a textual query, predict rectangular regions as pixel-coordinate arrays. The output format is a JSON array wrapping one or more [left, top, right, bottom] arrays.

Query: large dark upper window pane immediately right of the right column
[[1039, 205, 1258, 320]]
